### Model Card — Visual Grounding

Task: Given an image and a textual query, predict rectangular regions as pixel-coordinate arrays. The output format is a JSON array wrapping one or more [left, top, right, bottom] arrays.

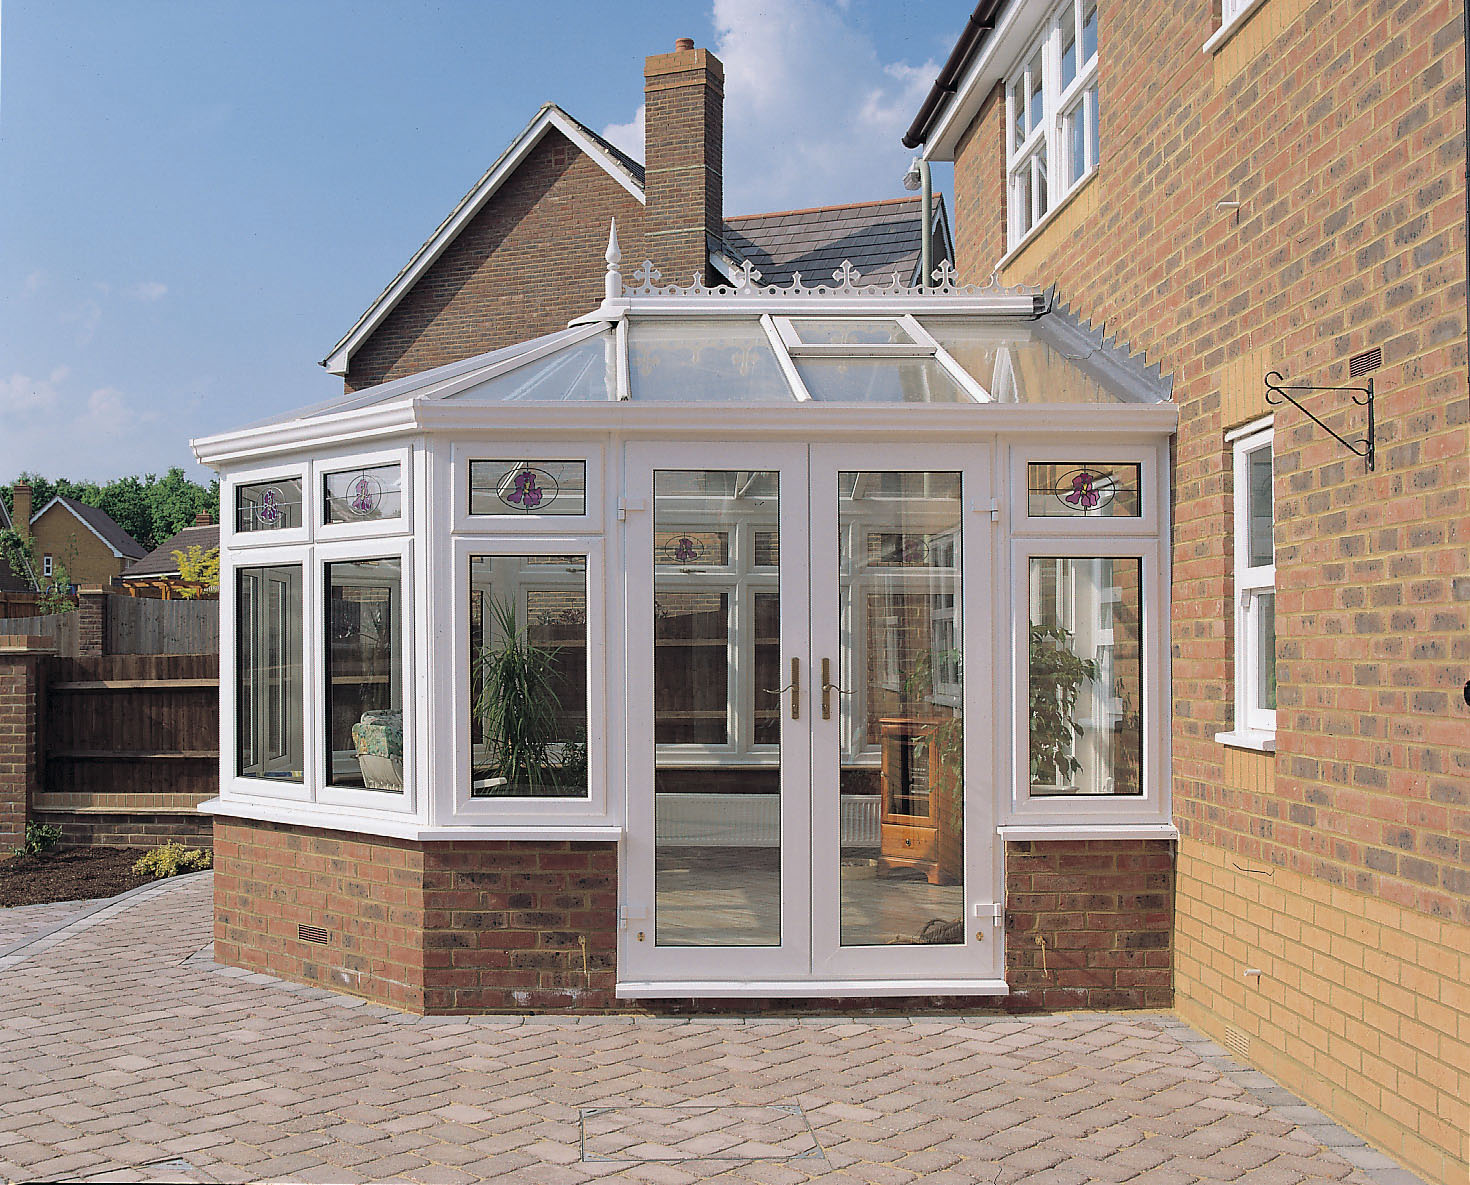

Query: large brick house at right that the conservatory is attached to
[[906, 0, 1470, 1182]]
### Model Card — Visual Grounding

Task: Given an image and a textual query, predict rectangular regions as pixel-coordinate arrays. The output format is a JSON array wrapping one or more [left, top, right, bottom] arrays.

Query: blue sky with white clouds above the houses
[[0, 0, 970, 481]]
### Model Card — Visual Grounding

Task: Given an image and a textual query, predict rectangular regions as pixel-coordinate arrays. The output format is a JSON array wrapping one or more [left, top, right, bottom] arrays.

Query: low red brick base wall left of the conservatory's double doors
[[215, 817, 617, 1013]]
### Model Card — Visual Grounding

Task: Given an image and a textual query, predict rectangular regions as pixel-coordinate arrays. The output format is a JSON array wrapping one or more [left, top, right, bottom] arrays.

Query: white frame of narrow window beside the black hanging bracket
[[1216, 420, 1276, 751]]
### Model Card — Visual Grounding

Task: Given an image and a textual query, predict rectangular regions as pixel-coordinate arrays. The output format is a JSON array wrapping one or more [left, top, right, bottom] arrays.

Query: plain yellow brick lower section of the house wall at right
[[1175, 835, 1470, 1185]]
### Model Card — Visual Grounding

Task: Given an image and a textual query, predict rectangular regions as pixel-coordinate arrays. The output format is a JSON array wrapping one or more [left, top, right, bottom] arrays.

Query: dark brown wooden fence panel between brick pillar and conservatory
[[32, 655, 219, 845]]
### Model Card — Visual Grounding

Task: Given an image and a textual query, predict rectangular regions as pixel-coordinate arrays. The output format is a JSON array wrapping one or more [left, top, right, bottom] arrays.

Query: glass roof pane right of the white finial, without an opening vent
[[628, 318, 795, 403]]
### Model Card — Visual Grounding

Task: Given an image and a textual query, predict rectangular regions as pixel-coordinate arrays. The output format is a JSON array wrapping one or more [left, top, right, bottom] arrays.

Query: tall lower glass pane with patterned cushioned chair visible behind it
[[326, 560, 403, 794]]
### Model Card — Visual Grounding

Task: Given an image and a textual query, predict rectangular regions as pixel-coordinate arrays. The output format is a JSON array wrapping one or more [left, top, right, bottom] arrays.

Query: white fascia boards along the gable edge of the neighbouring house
[[322, 103, 648, 375]]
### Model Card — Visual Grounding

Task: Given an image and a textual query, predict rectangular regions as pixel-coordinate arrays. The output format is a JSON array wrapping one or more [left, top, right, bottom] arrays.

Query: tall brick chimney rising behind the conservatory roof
[[644, 37, 725, 284]]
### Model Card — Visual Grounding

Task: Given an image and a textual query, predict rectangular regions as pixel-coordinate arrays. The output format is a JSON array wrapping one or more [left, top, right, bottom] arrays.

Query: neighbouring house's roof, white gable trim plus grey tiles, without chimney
[[322, 103, 954, 375]]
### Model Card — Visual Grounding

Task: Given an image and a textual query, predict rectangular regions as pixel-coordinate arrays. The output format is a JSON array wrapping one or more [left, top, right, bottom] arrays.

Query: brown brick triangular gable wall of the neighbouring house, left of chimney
[[345, 128, 650, 391]]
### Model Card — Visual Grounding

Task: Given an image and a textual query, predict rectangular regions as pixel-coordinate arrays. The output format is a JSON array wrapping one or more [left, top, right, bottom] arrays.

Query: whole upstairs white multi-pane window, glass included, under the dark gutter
[[1005, 0, 1098, 247]]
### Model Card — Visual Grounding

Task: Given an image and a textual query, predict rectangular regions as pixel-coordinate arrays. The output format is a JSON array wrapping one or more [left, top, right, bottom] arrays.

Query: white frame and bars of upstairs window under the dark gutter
[[1005, 0, 1101, 250]]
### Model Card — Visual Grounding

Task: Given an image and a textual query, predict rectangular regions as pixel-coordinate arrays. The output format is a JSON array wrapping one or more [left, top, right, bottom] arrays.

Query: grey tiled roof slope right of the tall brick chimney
[[725, 196, 953, 285]]
